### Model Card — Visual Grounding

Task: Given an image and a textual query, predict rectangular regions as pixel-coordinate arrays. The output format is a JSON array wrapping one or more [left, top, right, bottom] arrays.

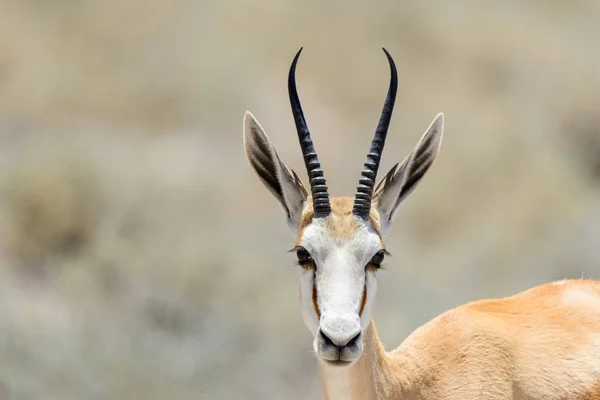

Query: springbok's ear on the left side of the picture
[[244, 111, 308, 233]]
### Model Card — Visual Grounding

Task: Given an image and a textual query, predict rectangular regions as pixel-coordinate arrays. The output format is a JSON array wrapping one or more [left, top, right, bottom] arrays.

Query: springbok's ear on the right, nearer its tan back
[[373, 113, 444, 233]]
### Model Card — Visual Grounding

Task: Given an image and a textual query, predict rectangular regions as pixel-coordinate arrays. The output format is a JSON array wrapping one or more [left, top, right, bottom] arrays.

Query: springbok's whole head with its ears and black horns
[[244, 49, 444, 366]]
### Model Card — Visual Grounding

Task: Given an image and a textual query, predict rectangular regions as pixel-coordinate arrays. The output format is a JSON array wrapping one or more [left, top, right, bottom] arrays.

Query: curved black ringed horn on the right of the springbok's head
[[352, 49, 398, 220]]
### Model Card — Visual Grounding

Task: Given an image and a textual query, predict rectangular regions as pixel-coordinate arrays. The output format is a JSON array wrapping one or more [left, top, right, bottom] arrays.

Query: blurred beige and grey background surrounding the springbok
[[0, 0, 600, 400]]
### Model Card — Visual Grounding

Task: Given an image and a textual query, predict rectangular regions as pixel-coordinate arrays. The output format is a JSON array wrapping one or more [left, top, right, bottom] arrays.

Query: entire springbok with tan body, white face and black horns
[[243, 49, 600, 400]]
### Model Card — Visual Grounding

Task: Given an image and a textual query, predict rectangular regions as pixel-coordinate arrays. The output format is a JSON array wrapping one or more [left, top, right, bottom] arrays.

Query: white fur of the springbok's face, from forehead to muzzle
[[300, 216, 381, 365]]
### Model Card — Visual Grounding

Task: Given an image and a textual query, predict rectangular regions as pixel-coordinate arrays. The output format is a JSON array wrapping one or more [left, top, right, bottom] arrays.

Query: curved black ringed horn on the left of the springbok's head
[[288, 48, 331, 218]]
